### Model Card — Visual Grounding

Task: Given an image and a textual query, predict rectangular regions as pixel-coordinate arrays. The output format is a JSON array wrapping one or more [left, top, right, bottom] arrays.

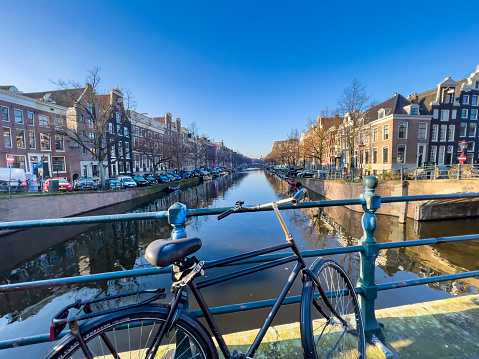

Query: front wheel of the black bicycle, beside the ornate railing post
[[300, 258, 366, 359]]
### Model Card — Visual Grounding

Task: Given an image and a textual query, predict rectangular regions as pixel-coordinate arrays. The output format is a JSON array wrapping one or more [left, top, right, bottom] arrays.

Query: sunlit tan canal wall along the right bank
[[297, 178, 479, 221]]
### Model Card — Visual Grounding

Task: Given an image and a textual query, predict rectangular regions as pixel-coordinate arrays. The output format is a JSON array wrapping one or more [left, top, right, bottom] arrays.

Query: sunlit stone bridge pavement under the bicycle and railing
[[225, 295, 479, 359]]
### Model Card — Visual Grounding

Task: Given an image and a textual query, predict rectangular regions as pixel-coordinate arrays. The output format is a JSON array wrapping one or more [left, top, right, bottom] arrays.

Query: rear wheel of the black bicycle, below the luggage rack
[[44, 306, 218, 359]]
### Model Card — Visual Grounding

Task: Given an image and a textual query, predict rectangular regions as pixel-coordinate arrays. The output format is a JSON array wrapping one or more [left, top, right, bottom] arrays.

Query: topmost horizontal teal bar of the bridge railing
[[0, 192, 479, 230]]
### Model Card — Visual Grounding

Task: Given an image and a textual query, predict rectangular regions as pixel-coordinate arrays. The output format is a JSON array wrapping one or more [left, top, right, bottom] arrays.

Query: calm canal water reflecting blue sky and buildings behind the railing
[[0, 170, 479, 358]]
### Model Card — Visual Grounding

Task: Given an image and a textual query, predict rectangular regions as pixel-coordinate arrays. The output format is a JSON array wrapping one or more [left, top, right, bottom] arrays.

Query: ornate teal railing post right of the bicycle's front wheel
[[358, 176, 381, 335]]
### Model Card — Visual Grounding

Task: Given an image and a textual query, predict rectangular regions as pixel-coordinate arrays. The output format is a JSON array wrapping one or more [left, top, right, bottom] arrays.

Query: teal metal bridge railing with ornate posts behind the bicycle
[[0, 176, 479, 349]]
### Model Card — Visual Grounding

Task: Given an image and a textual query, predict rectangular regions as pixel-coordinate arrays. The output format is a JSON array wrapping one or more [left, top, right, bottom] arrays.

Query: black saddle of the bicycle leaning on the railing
[[145, 237, 202, 268]]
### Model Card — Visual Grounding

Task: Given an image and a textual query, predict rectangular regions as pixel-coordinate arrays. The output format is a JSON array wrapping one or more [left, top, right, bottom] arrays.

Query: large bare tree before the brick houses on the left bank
[[51, 68, 134, 186]]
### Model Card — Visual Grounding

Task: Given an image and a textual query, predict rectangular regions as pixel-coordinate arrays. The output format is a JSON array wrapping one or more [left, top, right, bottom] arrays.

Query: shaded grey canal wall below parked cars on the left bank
[[0, 177, 200, 222]]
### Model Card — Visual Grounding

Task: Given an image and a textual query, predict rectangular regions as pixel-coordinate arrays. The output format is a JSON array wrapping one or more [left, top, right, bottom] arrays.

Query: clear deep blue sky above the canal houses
[[0, 0, 479, 157]]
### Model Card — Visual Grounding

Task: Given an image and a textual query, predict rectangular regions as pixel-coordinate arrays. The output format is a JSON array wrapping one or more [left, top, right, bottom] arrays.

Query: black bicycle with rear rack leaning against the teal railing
[[45, 189, 366, 359]]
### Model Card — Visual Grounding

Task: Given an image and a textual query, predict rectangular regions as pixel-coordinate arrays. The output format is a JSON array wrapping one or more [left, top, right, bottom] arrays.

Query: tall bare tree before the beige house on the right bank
[[338, 78, 370, 172]]
